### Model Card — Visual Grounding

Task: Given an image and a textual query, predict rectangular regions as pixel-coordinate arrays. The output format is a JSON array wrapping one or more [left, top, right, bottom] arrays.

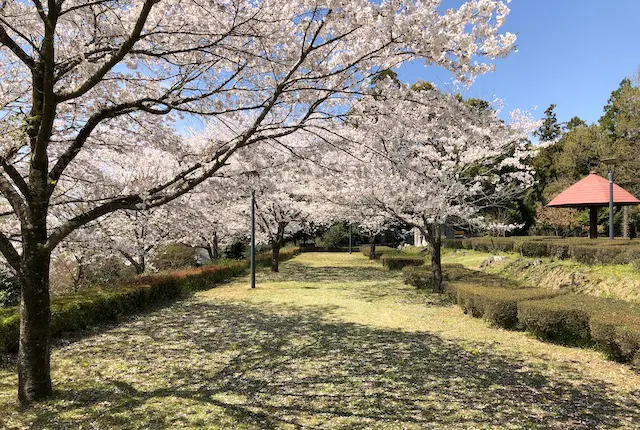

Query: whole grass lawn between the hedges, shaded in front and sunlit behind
[[0, 253, 640, 429]]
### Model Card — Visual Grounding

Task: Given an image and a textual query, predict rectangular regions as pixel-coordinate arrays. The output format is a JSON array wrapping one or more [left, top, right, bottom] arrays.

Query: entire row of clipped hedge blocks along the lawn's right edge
[[402, 264, 640, 368]]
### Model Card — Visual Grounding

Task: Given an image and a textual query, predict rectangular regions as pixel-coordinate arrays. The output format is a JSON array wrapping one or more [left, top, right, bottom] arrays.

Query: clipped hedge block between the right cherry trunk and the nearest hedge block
[[456, 285, 561, 329]]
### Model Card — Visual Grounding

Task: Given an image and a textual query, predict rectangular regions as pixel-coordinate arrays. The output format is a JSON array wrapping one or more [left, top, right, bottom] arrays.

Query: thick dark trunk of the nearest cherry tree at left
[[18, 244, 52, 405]]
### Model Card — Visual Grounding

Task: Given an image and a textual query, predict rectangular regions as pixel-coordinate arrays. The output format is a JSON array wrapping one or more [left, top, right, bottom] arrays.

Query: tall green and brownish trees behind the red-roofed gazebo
[[528, 68, 640, 235]]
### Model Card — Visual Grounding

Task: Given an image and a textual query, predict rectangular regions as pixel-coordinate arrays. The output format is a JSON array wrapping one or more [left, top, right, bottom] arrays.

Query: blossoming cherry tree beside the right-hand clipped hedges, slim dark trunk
[[330, 85, 537, 291]]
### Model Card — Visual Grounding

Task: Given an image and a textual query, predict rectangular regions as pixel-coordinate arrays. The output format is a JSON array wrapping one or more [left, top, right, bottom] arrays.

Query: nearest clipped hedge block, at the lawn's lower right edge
[[518, 294, 640, 365]]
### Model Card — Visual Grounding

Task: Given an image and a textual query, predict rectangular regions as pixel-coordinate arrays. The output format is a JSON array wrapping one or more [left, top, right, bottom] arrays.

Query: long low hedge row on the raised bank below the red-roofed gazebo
[[443, 236, 640, 265]]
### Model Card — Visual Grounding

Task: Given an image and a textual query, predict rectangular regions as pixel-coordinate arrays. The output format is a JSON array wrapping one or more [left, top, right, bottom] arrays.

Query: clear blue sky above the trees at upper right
[[397, 0, 640, 123]]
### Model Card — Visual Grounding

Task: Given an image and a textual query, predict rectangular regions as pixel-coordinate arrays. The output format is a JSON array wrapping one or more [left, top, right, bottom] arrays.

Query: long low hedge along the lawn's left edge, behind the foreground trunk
[[0, 261, 247, 352]]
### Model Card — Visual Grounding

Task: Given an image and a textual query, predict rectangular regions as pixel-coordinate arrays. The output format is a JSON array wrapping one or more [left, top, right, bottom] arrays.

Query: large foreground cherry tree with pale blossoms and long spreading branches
[[0, 0, 515, 403]]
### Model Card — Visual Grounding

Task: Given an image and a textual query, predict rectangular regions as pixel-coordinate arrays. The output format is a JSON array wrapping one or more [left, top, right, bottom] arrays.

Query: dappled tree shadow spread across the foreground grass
[[15, 301, 640, 429]]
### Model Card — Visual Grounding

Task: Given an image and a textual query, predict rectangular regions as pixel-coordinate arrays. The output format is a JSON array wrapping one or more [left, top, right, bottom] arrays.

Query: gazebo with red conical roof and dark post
[[547, 172, 640, 239]]
